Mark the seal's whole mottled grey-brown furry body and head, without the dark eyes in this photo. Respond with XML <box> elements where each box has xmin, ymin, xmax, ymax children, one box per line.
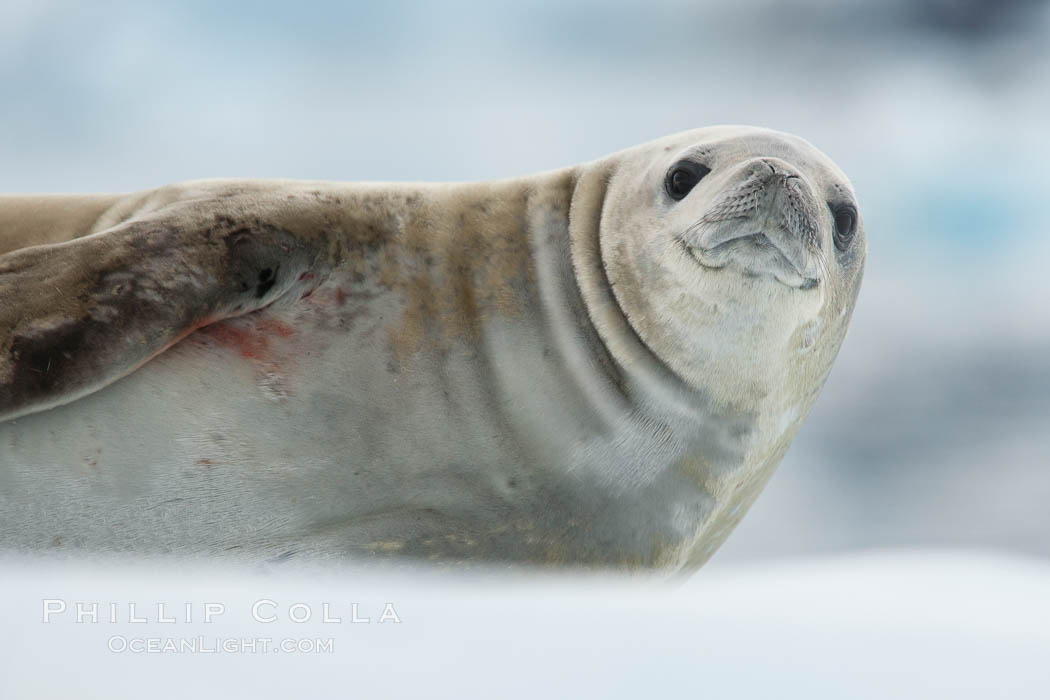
<box><xmin>0</xmin><ymin>127</ymin><xmax>864</xmax><ymax>570</ymax></box>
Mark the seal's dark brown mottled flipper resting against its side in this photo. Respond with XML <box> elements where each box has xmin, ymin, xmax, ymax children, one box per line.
<box><xmin>0</xmin><ymin>203</ymin><xmax>318</xmax><ymax>421</ymax></box>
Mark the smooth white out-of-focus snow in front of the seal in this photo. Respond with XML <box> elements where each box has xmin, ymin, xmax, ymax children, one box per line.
<box><xmin>0</xmin><ymin>550</ymin><xmax>1050</xmax><ymax>700</ymax></box>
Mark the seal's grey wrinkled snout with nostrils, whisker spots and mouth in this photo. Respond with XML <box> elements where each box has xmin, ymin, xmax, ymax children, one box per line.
<box><xmin>685</xmin><ymin>157</ymin><xmax>821</xmax><ymax>289</ymax></box>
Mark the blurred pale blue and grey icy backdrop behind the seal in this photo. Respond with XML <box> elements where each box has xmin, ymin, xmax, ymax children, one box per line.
<box><xmin>0</xmin><ymin>0</ymin><xmax>1050</xmax><ymax>566</ymax></box>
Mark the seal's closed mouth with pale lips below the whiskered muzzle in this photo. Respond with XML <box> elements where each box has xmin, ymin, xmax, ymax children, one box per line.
<box><xmin>683</xmin><ymin>232</ymin><xmax>820</xmax><ymax>290</ymax></box>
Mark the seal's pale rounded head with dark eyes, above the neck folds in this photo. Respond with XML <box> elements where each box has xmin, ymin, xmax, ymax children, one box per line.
<box><xmin>579</xmin><ymin>126</ymin><xmax>865</xmax><ymax>416</ymax></box>
